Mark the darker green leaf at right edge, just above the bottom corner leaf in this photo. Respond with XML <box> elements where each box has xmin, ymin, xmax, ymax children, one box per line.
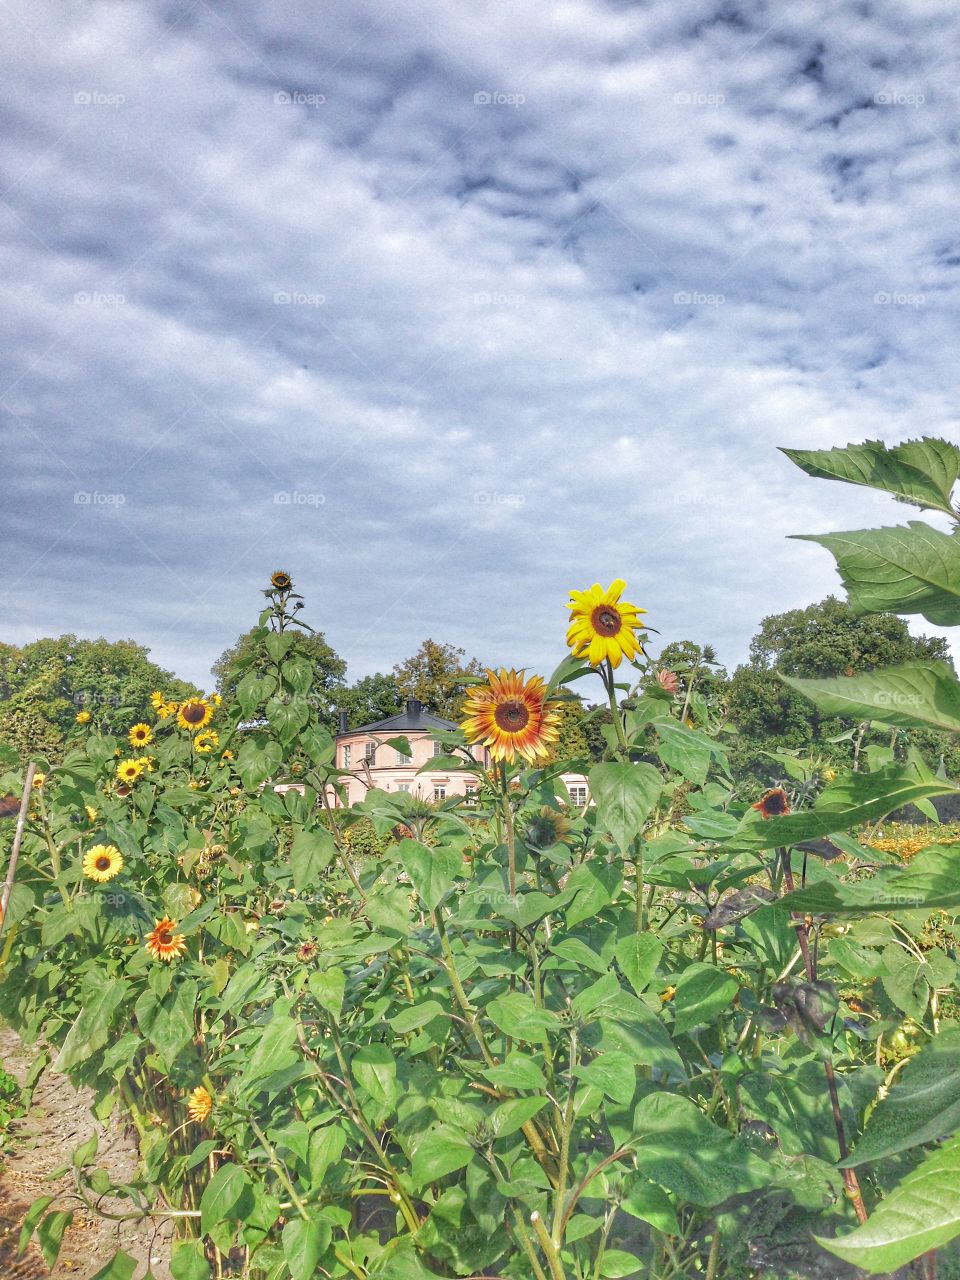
<box><xmin>841</xmin><ymin>1028</ymin><xmax>960</xmax><ymax>1169</ymax></box>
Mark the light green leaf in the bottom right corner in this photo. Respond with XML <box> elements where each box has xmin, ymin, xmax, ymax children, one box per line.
<box><xmin>817</xmin><ymin>1137</ymin><xmax>960</xmax><ymax>1275</ymax></box>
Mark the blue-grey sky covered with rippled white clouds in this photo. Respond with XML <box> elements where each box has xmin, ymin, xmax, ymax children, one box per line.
<box><xmin>0</xmin><ymin>0</ymin><xmax>960</xmax><ymax>684</ymax></box>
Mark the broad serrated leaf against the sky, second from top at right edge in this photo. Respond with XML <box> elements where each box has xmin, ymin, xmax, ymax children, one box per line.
<box><xmin>795</xmin><ymin>520</ymin><xmax>960</xmax><ymax>627</ymax></box>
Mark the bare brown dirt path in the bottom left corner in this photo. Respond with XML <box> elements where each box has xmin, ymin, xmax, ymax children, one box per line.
<box><xmin>0</xmin><ymin>1027</ymin><xmax>170</xmax><ymax>1280</ymax></box>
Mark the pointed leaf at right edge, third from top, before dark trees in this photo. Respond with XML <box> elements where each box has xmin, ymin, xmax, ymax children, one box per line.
<box><xmin>780</xmin><ymin>662</ymin><xmax>960</xmax><ymax>733</ymax></box>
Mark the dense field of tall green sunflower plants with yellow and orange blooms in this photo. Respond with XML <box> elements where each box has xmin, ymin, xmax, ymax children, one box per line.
<box><xmin>0</xmin><ymin>439</ymin><xmax>960</xmax><ymax>1280</ymax></box>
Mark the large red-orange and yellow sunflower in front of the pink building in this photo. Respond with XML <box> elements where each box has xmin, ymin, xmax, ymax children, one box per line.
<box><xmin>461</xmin><ymin>667</ymin><xmax>559</xmax><ymax>764</ymax></box>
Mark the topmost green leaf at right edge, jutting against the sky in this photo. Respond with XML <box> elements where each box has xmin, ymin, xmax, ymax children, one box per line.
<box><xmin>781</xmin><ymin>436</ymin><xmax>960</xmax><ymax>515</ymax></box>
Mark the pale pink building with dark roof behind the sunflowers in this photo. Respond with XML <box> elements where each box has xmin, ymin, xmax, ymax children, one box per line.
<box><xmin>337</xmin><ymin>698</ymin><xmax>588</xmax><ymax>805</ymax></box>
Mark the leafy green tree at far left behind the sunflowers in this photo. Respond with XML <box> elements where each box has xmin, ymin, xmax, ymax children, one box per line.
<box><xmin>0</xmin><ymin>635</ymin><xmax>198</xmax><ymax>759</ymax></box>
